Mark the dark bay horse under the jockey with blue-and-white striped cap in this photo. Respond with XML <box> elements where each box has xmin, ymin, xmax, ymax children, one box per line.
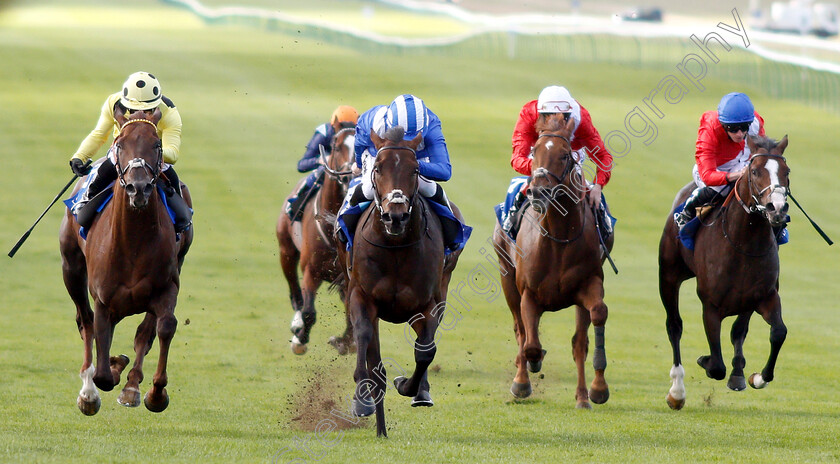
<box><xmin>339</xmin><ymin>126</ymin><xmax>463</xmax><ymax>436</ymax></box>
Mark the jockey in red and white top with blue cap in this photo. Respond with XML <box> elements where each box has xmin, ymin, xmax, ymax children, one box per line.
<box><xmin>674</xmin><ymin>92</ymin><xmax>764</xmax><ymax>229</ymax></box>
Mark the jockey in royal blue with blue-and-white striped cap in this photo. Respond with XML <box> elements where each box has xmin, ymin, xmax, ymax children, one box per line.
<box><xmin>338</xmin><ymin>94</ymin><xmax>466</xmax><ymax>251</ymax></box>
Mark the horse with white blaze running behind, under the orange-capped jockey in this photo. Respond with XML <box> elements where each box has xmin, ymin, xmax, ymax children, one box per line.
<box><xmin>277</xmin><ymin>128</ymin><xmax>356</xmax><ymax>355</ymax></box>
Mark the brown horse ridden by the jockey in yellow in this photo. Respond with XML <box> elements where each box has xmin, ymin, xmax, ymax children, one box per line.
<box><xmin>59</xmin><ymin>111</ymin><xmax>193</xmax><ymax>415</ymax></box>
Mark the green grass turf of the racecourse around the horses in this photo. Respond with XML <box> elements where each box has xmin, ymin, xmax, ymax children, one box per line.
<box><xmin>0</xmin><ymin>2</ymin><xmax>840</xmax><ymax>463</ymax></box>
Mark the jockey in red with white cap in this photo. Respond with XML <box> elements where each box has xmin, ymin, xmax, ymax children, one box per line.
<box><xmin>502</xmin><ymin>85</ymin><xmax>612</xmax><ymax>236</ymax></box>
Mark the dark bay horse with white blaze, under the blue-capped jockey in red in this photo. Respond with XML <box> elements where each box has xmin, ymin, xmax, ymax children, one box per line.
<box><xmin>659</xmin><ymin>136</ymin><xmax>790</xmax><ymax>409</ymax></box>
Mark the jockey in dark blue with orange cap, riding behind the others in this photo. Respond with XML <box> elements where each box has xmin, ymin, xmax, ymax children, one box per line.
<box><xmin>286</xmin><ymin>105</ymin><xmax>359</xmax><ymax>221</ymax></box>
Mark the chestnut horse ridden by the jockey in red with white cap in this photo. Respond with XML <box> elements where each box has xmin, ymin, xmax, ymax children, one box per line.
<box><xmin>493</xmin><ymin>115</ymin><xmax>613</xmax><ymax>409</ymax></box>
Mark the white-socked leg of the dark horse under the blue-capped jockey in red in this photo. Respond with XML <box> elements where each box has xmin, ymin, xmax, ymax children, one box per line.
<box><xmin>659</xmin><ymin>259</ymin><xmax>685</xmax><ymax>410</ymax></box>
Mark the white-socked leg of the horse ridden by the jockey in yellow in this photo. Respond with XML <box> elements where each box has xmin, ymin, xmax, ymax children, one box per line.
<box><xmin>60</xmin><ymin>227</ymin><xmax>102</xmax><ymax>416</ymax></box>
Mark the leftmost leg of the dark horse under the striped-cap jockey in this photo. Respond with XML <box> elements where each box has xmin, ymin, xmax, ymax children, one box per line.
<box><xmin>347</xmin><ymin>290</ymin><xmax>376</xmax><ymax>417</ymax></box>
